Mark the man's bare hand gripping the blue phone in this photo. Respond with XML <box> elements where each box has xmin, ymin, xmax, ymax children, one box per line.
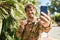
<box><xmin>40</xmin><ymin>11</ymin><xmax>51</xmax><ymax>27</ymax></box>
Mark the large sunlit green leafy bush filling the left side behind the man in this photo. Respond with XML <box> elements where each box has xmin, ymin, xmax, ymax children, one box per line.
<box><xmin>0</xmin><ymin>0</ymin><xmax>38</xmax><ymax>40</ymax></box>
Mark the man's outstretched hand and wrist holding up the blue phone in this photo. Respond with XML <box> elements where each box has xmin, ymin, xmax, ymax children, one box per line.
<box><xmin>39</xmin><ymin>11</ymin><xmax>51</xmax><ymax>32</ymax></box>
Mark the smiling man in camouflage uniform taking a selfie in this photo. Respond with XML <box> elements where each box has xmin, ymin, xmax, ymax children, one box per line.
<box><xmin>16</xmin><ymin>4</ymin><xmax>50</xmax><ymax>40</ymax></box>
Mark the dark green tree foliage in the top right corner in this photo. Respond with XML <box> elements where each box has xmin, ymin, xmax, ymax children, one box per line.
<box><xmin>50</xmin><ymin>0</ymin><xmax>60</xmax><ymax>13</ymax></box>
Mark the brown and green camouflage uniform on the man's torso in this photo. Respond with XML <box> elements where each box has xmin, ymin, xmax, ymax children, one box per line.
<box><xmin>19</xmin><ymin>20</ymin><xmax>50</xmax><ymax>40</ymax></box>
